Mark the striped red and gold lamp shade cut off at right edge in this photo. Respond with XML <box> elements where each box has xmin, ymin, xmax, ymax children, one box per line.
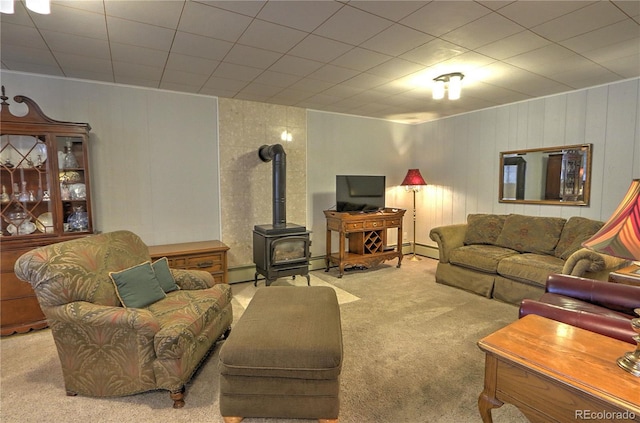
<box><xmin>582</xmin><ymin>179</ymin><xmax>640</xmax><ymax>260</ymax></box>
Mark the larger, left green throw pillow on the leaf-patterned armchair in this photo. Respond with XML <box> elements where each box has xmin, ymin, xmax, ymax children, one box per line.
<box><xmin>109</xmin><ymin>261</ymin><xmax>166</xmax><ymax>308</ymax></box>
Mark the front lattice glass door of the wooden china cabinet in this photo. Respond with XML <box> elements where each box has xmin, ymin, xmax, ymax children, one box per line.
<box><xmin>0</xmin><ymin>134</ymin><xmax>55</xmax><ymax>237</ymax></box>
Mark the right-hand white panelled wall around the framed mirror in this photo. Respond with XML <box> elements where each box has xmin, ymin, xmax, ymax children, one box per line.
<box><xmin>412</xmin><ymin>79</ymin><xmax>640</xmax><ymax>252</ymax></box>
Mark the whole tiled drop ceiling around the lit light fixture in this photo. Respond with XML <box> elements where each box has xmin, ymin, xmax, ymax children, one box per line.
<box><xmin>0</xmin><ymin>0</ymin><xmax>640</xmax><ymax>123</ymax></box>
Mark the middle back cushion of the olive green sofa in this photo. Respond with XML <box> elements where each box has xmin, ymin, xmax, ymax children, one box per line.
<box><xmin>496</xmin><ymin>214</ymin><xmax>566</xmax><ymax>255</ymax></box>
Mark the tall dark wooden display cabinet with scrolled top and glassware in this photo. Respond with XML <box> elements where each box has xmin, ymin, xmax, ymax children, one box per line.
<box><xmin>0</xmin><ymin>87</ymin><xmax>94</xmax><ymax>335</ymax></box>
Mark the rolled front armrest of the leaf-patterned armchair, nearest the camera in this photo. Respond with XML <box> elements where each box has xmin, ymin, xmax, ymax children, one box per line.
<box><xmin>43</xmin><ymin>301</ymin><xmax>160</xmax><ymax>338</ymax></box>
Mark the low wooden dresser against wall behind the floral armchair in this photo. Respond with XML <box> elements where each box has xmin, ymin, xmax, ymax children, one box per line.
<box><xmin>149</xmin><ymin>241</ymin><xmax>229</xmax><ymax>283</ymax></box>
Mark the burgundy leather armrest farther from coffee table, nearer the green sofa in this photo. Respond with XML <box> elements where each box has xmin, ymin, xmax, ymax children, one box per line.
<box><xmin>545</xmin><ymin>274</ymin><xmax>640</xmax><ymax>315</ymax></box>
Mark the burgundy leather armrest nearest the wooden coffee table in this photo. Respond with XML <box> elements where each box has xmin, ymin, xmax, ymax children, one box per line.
<box><xmin>519</xmin><ymin>299</ymin><xmax>636</xmax><ymax>345</ymax></box>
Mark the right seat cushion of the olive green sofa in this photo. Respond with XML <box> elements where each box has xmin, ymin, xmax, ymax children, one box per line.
<box><xmin>498</xmin><ymin>253</ymin><xmax>564</xmax><ymax>286</ymax></box>
